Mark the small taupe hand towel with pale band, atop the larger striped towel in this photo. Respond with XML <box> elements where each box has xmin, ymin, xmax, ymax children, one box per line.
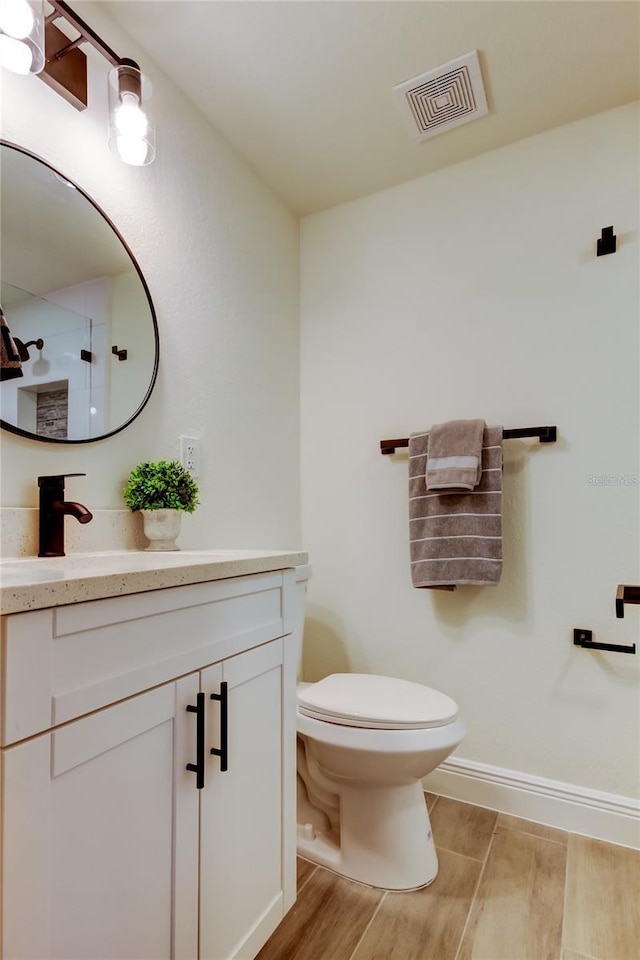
<box><xmin>427</xmin><ymin>420</ymin><xmax>486</xmax><ymax>490</ymax></box>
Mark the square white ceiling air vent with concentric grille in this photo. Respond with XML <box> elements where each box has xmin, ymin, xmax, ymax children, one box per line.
<box><xmin>393</xmin><ymin>50</ymin><xmax>489</xmax><ymax>140</ymax></box>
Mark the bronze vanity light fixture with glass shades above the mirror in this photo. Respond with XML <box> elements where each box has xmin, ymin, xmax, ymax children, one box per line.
<box><xmin>0</xmin><ymin>0</ymin><xmax>156</xmax><ymax>166</ymax></box>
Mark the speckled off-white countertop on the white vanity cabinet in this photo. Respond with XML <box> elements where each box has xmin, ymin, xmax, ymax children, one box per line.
<box><xmin>0</xmin><ymin>550</ymin><xmax>309</xmax><ymax>614</ymax></box>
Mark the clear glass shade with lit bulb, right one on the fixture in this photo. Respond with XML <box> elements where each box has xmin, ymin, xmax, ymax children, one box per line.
<box><xmin>109</xmin><ymin>60</ymin><xmax>156</xmax><ymax>167</ymax></box>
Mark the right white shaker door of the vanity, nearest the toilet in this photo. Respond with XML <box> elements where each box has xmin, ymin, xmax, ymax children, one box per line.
<box><xmin>200</xmin><ymin>640</ymin><xmax>284</xmax><ymax>960</ymax></box>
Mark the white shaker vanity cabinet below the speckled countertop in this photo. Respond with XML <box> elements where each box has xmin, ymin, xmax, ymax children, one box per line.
<box><xmin>1</xmin><ymin>570</ymin><xmax>295</xmax><ymax>960</ymax></box>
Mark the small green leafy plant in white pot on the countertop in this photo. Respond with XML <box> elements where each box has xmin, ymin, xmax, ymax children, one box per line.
<box><xmin>123</xmin><ymin>460</ymin><xmax>200</xmax><ymax>550</ymax></box>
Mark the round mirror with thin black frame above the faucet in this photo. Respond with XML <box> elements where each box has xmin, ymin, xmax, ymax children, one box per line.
<box><xmin>0</xmin><ymin>141</ymin><xmax>159</xmax><ymax>443</ymax></box>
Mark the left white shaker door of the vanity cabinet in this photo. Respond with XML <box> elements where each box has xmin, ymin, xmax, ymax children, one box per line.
<box><xmin>2</xmin><ymin>674</ymin><xmax>199</xmax><ymax>960</ymax></box>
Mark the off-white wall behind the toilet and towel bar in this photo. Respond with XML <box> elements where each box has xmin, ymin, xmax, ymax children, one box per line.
<box><xmin>301</xmin><ymin>105</ymin><xmax>640</xmax><ymax>796</ymax></box>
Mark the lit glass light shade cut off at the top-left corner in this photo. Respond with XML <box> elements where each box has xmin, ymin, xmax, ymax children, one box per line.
<box><xmin>0</xmin><ymin>0</ymin><xmax>44</xmax><ymax>73</ymax></box>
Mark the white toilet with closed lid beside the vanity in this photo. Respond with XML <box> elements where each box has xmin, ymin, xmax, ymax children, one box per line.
<box><xmin>296</xmin><ymin>567</ymin><xmax>465</xmax><ymax>890</ymax></box>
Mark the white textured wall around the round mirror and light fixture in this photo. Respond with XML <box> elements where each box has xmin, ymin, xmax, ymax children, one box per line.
<box><xmin>1</xmin><ymin>4</ymin><xmax>299</xmax><ymax>548</ymax></box>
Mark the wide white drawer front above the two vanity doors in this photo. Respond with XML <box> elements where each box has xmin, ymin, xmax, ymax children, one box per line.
<box><xmin>2</xmin><ymin>571</ymin><xmax>289</xmax><ymax>746</ymax></box>
